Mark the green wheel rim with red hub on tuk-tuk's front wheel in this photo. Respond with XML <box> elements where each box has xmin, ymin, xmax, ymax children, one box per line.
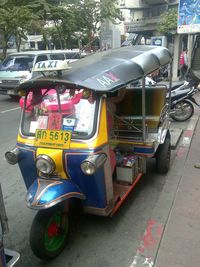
<box><xmin>44</xmin><ymin>211</ymin><xmax>69</xmax><ymax>251</ymax></box>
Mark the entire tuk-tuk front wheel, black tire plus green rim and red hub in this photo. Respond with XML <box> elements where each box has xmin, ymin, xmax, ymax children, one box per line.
<box><xmin>29</xmin><ymin>206</ymin><xmax>69</xmax><ymax>260</ymax></box>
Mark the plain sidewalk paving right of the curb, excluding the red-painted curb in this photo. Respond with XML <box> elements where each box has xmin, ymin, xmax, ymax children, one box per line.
<box><xmin>154</xmin><ymin>112</ymin><xmax>200</xmax><ymax>267</ymax></box>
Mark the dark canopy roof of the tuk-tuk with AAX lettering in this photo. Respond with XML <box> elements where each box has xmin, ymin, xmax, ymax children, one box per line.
<box><xmin>20</xmin><ymin>45</ymin><xmax>172</xmax><ymax>92</ymax></box>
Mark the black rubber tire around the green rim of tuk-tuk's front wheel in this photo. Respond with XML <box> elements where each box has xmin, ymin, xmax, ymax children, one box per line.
<box><xmin>29</xmin><ymin>205</ymin><xmax>69</xmax><ymax>260</ymax></box>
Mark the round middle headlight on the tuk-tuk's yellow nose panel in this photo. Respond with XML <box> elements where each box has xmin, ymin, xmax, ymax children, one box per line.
<box><xmin>35</xmin><ymin>155</ymin><xmax>56</xmax><ymax>174</ymax></box>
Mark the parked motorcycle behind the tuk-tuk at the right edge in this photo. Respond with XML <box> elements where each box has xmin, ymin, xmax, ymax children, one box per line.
<box><xmin>167</xmin><ymin>81</ymin><xmax>200</xmax><ymax>122</ymax></box>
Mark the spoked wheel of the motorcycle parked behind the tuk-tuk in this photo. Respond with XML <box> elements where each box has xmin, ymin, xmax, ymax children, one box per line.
<box><xmin>170</xmin><ymin>100</ymin><xmax>194</xmax><ymax>121</ymax></box>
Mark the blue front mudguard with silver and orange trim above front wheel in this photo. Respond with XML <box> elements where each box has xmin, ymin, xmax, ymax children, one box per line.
<box><xmin>26</xmin><ymin>178</ymin><xmax>85</xmax><ymax>209</ymax></box>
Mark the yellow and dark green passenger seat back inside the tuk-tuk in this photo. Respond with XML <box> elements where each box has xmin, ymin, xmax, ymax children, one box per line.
<box><xmin>114</xmin><ymin>86</ymin><xmax>167</xmax><ymax>139</ymax></box>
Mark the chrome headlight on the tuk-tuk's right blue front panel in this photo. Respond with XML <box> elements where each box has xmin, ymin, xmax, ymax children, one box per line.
<box><xmin>81</xmin><ymin>153</ymin><xmax>107</xmax><ymax>175</ymax></box>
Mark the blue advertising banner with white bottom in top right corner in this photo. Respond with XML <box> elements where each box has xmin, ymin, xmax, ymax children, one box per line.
<box><xmin>177</xmin><ymin>0</ymin><xmax>200</xmax><ymax>33</ymax></box>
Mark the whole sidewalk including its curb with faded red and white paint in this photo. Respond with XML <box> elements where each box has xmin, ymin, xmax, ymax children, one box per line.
<box><xmin>130</xmin><ymin>108</ymin><xmax>200</xmax><ymax>267</ymax></box>
